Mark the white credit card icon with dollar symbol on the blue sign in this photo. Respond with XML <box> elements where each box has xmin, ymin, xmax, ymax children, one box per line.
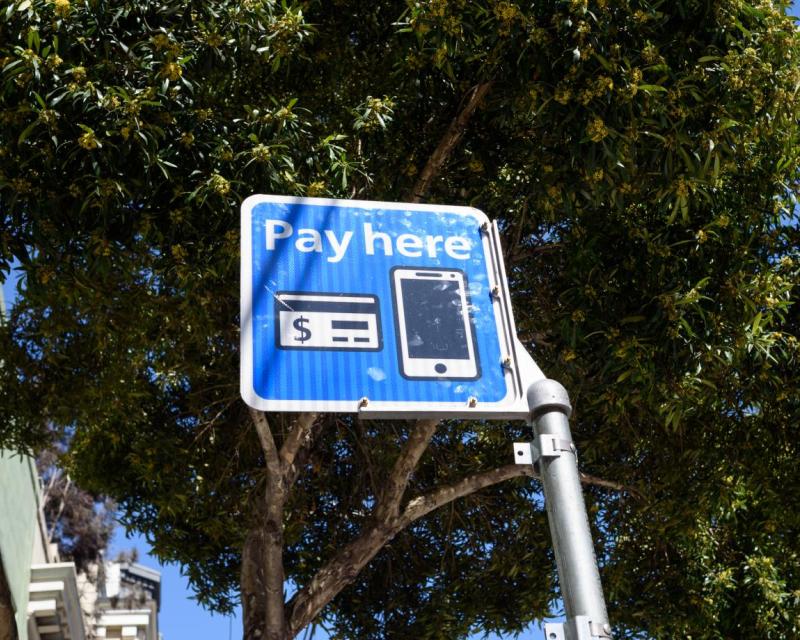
<box><xmin>275</xmin><ymin>291</ymin><xmax>383</xmax><ymax>351</ymax></box>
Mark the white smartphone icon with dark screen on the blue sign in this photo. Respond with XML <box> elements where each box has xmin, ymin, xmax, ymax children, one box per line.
<box><xmin>391</xmin><ymin>267</ymin><xmax>480</xmax><ymax>380</ymax></box>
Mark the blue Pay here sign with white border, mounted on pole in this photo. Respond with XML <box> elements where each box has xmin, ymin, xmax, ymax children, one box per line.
<box><xmin>241</xmin><ymin>195</ymin><xmax>527</xmax><ymax>418</ymax></box>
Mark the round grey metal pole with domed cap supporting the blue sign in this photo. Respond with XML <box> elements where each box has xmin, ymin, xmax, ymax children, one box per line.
<box><xmin>528</xmin><ymin>379</ymin><xmax>611</xmax><ymax>640</ymax></box>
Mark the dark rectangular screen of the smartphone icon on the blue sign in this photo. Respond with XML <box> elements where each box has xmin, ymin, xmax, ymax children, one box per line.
<box><xmin>401</xmin><ymin>279</ymin><xmax>469</xmax><ymax>360</ymax></box>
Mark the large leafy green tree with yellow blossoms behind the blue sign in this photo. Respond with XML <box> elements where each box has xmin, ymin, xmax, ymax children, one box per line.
<box><xmin>0</xmin><ymin>0</ymin><xmax>800</xmax><ymax>638</ymax></box>
